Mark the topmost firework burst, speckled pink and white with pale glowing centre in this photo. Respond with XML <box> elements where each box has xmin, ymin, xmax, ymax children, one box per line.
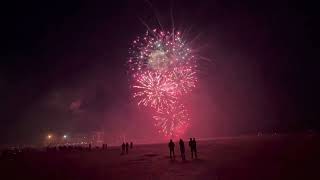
<box><xmin>128</xmin><ymin>29</ymin><xmax>195</xmax><ymax>72</ymax></box>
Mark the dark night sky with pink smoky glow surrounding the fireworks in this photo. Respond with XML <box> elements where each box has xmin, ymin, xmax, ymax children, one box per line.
<box><xmin>0</xmin><ymin>0</ymin><xmax>320</xmax><ymax>144</ymax></box>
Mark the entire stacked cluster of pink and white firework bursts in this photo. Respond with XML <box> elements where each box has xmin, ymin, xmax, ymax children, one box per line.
<box><xmin>128</xmin><ymin>29</ymin><xmax>197</xmax><ymax>137</ymax></box>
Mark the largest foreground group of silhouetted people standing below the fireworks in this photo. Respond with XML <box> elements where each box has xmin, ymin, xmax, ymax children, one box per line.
<box><xmin>168</xmin><ymin>138</ymin><xmax>198</xmax><ymax>161</ymax></box>
